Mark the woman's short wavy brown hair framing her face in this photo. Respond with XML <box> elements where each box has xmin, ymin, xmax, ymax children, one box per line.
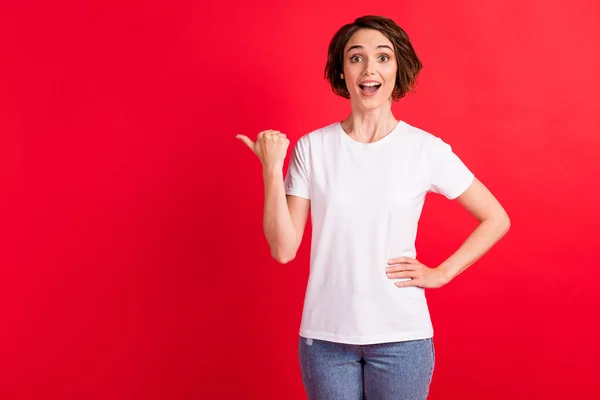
<box><xmin>325</xmin><ymin>15</ymin><xmax>423</xmax><ymax>101</ymax></box>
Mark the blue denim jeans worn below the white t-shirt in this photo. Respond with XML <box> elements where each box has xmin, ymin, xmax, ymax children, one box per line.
<box><xmin>298</xmin><ymin>337</ymin><xmax>435</xmax><ymax>400</ymax></box>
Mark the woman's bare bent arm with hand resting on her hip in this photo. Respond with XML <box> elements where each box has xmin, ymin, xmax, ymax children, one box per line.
<box><xmin>386</xmin><ymin>178</ymin><xmax>510</xmax><ymax>288</ymax></box>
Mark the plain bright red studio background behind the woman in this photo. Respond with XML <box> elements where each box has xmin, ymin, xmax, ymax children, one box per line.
<box><xmin>0</xmin><ymin>0</ymin><xmax>600</xmax><ymax>400</ymax></box>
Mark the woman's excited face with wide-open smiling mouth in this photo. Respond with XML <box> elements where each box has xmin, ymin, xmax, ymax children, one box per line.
<box><xmin>343</xmin><ymin>29</ymin><xmax>398</xmax><ymax>109</ymax></box>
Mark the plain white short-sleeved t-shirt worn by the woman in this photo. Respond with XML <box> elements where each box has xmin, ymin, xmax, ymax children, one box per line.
<box><xmin>285</xmin><ymin>121</ymin><xmax>474</xmax><ymax>344</ymax></box>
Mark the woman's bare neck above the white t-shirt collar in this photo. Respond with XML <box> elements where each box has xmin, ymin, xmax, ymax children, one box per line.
<box><xmin>342</xmin><ymin>107</ymin><xmax>398</xmax><ymax>143</ymax></box>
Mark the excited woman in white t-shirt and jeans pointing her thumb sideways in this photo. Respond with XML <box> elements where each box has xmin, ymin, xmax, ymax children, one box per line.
<box><xmin>237</xmin><ymin>16</ymin><xmax>510</xmax><ymax>400</ymax></box>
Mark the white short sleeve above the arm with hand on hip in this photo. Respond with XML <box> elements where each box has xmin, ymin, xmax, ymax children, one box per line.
<box><xmin>427</xmin><ymin>137</ymin><xmax>475</xmax><ymax>200</ymax></box>
